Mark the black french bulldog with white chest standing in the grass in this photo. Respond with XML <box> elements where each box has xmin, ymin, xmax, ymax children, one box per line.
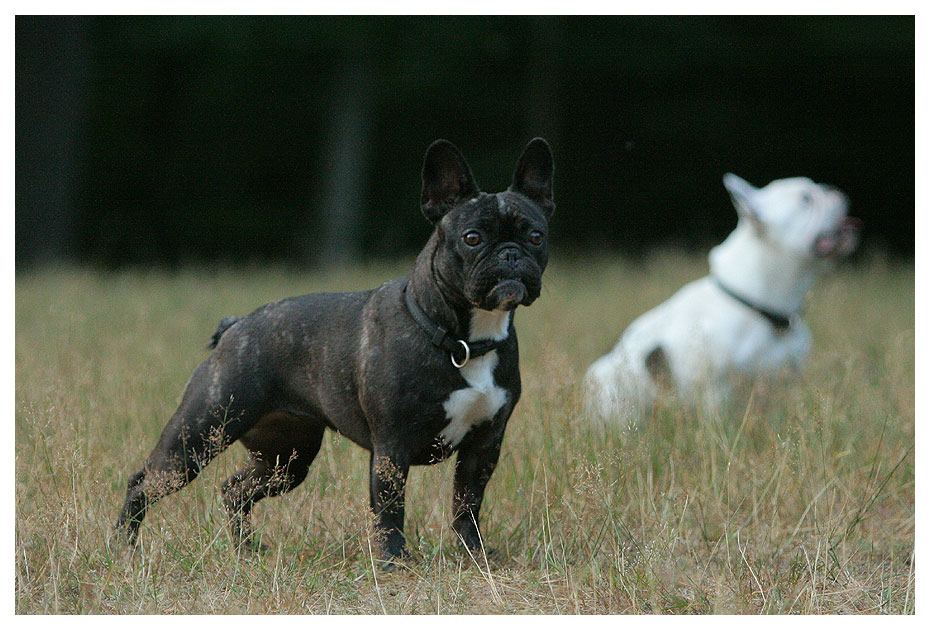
<box><xmin>117</xmin><ymin>138</ymin><xmax>555</xmax><ymax>568</ymax></box>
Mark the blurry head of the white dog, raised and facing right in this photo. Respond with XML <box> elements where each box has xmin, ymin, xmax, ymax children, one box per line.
<box><xmin>723</xmin><ymin>173</ymin><xmax>860</xmax><ymax>259</ymax></box>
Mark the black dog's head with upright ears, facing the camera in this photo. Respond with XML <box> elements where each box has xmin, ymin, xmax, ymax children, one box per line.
<box><xmin>423</xmin><ymin>138</ymin><xmax>555</xmax><ymax>311</ymax></box>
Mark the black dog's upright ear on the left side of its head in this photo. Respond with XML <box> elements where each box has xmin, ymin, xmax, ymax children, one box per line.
<box><xmin>420</xmin><ymin>139</ymin><xmax>481</xmax><ymax>223</ymax></box>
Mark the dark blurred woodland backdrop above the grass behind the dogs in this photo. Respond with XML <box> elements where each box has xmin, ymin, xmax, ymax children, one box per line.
<box><xmin>16</xmin><ymin>16</ymin><xmax>915</xmax><ymax>268</ymax></box>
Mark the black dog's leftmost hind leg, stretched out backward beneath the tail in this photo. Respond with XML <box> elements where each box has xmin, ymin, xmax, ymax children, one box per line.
<box><xmin>116</xmin><ymin>359</ymin><xmax>260</xmax><ymax>545</ymax></box>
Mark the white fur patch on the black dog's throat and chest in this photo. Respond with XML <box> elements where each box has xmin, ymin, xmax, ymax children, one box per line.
<box><xmin>439</xmin><ymin>309</ymin><xmax>510</xmax><ymax>448</ymax></box>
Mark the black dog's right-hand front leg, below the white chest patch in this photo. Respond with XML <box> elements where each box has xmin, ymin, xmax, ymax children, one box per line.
<box><xmin>452</xmin><ymin>427</ymin><xmax>503</xmax><ymax>551</ymax></box>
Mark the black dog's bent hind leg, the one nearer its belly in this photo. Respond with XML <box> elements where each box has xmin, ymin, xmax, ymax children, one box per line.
<box><xmin>223</xmin><ymin>413</ymin><xmax>325</xmax><ymax>551</ymax></box>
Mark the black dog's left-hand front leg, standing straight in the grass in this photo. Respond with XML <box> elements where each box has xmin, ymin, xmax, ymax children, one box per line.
<box><xmin>370</xmin><ymin>449</ymin><xmax>410</xmax><ymax>569</ymax></box>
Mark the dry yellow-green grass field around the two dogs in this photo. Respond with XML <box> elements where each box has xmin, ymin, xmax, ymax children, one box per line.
<box><xmin>15</xmin><ymin>255</ymin><xmax>915</xmax><ymax>613</ymax></box>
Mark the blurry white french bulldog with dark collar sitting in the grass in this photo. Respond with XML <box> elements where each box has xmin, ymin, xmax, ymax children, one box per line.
<box><xmin>585</xmin><ymin>173</ymin><xmax>859</xmax><ymax>424</ymax></box>
